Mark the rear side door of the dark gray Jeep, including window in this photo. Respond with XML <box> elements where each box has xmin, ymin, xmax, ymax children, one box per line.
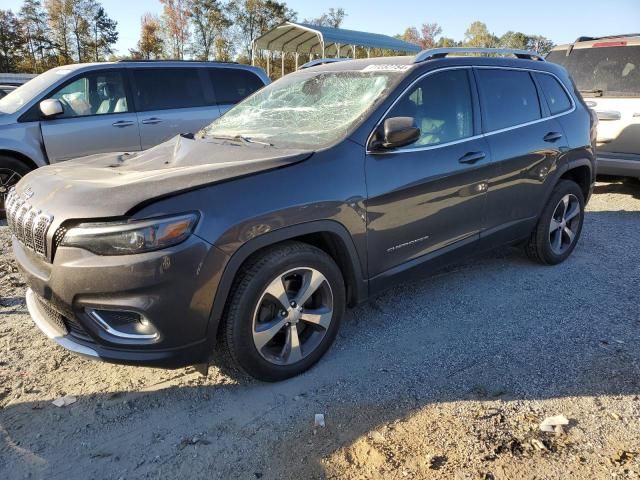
<box><xmin>474</xmin><ymin>67</ymin><xmax>573</xmax><ymax>242</ymax></box>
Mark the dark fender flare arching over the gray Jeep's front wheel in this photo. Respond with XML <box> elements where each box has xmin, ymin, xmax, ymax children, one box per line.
<box><xmin>207</xmin><ymin>220</ymin><xmax>368</xmax><ymax>345</ymax></box>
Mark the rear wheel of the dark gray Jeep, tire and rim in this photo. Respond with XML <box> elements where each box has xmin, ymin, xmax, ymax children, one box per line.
<box><xmin>526</xmin><ymin>180</ymin><xmax>584</xmax><ymax>265</ymax></box>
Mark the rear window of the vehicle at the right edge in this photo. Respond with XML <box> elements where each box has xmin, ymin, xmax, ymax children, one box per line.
<box><xmin>547</xmin><ymin>46</ymin><xmax>640</xmax><ymax>97</ymax></box>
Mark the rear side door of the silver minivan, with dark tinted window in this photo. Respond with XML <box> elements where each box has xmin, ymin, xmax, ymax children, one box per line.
<box><xmin>131</xmin><ymin>66</ymin><xmax>220</xmax><ymax>150</ymax></box>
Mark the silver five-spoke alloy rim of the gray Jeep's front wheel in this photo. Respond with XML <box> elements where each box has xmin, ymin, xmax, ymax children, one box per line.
<box><xmin>252</xmin><ymin>267</ymin><xmax>333</xmax><ymax>365</ymax></box>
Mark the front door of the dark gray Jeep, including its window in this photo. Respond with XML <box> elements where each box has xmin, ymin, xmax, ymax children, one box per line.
<box><xmin>366</xmin><ymin>68</ymin><xmax>493</xmax><ymax>277</ymax></box>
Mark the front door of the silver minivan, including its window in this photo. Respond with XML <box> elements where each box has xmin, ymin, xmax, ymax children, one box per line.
<box><xmin>40</xmin><ymin>70</ymin><xmax>140</xmax><ymax>163</ymax></box>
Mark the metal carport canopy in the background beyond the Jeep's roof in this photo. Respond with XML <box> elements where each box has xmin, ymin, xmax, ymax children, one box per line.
<box><xmin>253</xmin><ymin>22</ymin><xmax>420</xmax><ymax>57</ymax></box>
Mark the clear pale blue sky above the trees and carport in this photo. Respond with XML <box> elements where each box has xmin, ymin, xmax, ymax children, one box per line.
<box><xmin>0</xmin><ymin>0</ymin><xmax>640</xmax><ymax>54</ymax></box>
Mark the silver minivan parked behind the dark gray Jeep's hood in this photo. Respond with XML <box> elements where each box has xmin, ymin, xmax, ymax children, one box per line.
<box><xmin>0</xmin><ymin>61</ymin><xmax>269</xmax><ymax>216</ymax></box>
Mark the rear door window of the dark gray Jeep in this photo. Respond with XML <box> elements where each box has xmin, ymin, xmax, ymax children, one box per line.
<box><xmin>477</xmin><ymin>69</ymin><xmax>542</xmax><ymax>131</ymax></box>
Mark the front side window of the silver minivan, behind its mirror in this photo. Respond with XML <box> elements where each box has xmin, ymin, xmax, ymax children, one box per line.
<box><xmin>50</xmin><ymin>72</ymin><xmax>129</xmax><ymax>118</ymax></box>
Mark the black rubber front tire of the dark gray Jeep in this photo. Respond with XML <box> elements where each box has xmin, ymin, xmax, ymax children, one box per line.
<box><xmin>218</xmin><ymin>241</ymin><xmax>346</xmax><ymax>382</ymax></box>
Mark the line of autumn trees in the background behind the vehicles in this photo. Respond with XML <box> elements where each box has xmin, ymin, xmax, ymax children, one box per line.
<box><xmin>0</xmin><ymin>0</ymin><xmax>553</xmax><ymax>73</ymax></box>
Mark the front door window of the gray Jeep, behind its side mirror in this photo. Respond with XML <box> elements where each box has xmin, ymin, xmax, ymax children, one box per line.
<box><xmin>388</xmin><ymin>69</ymin><xmax>473</xmax><ymax>148</ymax></box>
